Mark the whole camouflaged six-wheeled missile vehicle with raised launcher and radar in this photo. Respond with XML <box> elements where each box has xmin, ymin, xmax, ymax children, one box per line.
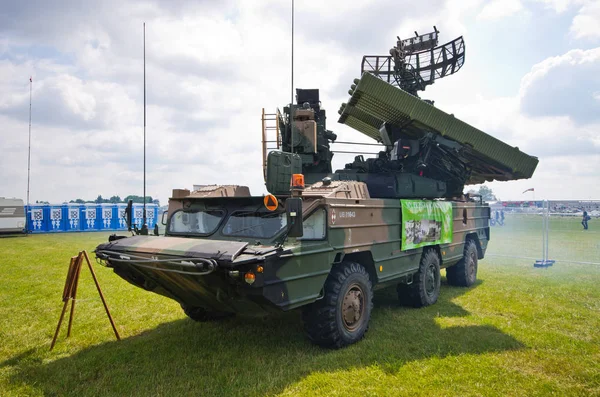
<box><xmin>96</xmin><ymin>29</ymin><xmax>537</xmax><ymax>348</ymax></box>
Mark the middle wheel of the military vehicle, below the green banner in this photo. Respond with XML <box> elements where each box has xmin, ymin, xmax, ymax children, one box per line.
<box><xmin>398</xmin><ymin>249</ymin><xmax>440</xmax><ymax>307</ymax></box>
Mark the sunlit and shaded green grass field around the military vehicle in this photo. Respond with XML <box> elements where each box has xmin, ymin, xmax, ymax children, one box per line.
<box><xmin>0</xmin><ymin>216</ymin><xmax>600</xmax><ymax>396</ymax></box>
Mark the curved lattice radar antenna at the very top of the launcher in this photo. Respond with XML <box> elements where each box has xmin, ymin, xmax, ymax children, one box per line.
<box><xmin>360</xmin><ymin>26</ymin><xmax>465</xmax><ymax>97</ymax></box>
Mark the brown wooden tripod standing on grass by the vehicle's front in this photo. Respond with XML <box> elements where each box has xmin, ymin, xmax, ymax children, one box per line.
<box><xmin>50</xmin><ymin>251</ymin><xmax>121</xmax><ymax>350</ymax></box>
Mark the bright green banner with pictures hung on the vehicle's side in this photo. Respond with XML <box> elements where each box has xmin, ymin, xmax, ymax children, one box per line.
<box><xmin>400</xmin><ymin>200</ymin><xmax>452</xmax><ymax>250</ymax></box>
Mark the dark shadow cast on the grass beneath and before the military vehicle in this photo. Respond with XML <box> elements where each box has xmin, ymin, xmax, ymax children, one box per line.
<box><xmin>0</xmin><ymin>280</ymin><xmax>523</xmax><ymax>396</ymax></box>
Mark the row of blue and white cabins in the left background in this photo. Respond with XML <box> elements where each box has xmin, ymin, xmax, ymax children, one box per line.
<box><xmin>25</xmin><ymin>203</ymin><xmax>158</xmax><ymax>233</ymax></box>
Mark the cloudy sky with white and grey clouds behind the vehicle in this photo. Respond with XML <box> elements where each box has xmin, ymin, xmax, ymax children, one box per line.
<box><xmin>0</xmin><ymin>0</ymin><xmax>600</xmax><ymax>204</ymax></box>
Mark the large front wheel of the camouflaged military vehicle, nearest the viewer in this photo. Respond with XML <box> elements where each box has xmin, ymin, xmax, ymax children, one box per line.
<box><xmin>302</xmin><ymin>262</ymin><xmax>373</xmax><ymax>349</ymax></box>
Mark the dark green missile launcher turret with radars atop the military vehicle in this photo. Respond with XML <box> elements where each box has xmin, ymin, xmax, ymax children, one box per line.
<box><xmin>264</xmin><ymin>26</ymin><xmax>538</xmax><ymax>198</ymax></box>
